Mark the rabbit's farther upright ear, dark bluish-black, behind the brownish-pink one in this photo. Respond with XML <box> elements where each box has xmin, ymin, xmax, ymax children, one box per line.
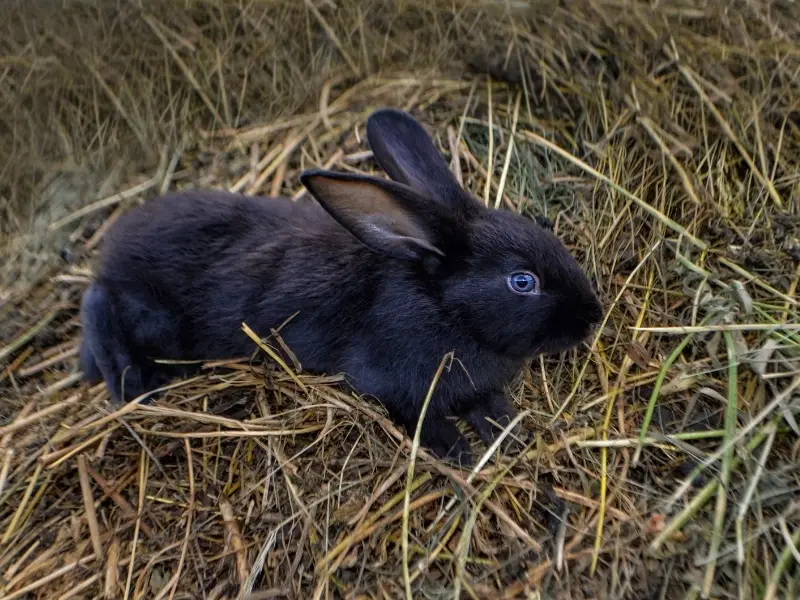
<box><xmin>367</xmin><ymin>108</ymin><xmax>467</xmax><ymax>208</ymax></box>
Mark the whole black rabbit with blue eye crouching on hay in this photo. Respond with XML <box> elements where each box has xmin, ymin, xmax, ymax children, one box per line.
<box><xmin>81</xmin><ymin>109</ymin><xmax>602</xmax><ymax>463</ymax></box>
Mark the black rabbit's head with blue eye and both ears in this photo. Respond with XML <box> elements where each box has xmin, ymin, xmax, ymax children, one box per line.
<box><xmin>301</xmin><ymin>109</ymin><xmax>603</xmax><ymax>359</ymax></box>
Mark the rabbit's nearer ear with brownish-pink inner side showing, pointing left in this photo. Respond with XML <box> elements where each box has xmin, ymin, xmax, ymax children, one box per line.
<box><xmin>300</xmin><ymin>171</ymin><xmax>444</xmax><ymax>260</ymax></box>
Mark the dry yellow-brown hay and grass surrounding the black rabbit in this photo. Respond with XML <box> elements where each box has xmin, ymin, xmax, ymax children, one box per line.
<box><xmin>0</xmin><ymin>0</ymin><xmax>800</xmax><ymax>600</ymax></box>
